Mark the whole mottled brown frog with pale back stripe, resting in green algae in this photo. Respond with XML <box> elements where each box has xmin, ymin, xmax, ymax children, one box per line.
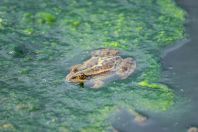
<box><xmin>66</xmin><ymin>49</ymin><xmax>136</xmax><ymax>88</ymax></box>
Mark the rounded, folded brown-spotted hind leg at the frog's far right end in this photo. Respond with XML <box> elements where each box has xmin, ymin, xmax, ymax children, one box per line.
<box><xmin>116</xmin><ymin>58</ymin><xmax>136</xmax><ymax>79</ymax></box>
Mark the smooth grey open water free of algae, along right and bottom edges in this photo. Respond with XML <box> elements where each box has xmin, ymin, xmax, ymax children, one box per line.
<box><xmin>115</xmin><ymin>0</ymin><xmax>198</xmax><ymax>132</ymax></box>
